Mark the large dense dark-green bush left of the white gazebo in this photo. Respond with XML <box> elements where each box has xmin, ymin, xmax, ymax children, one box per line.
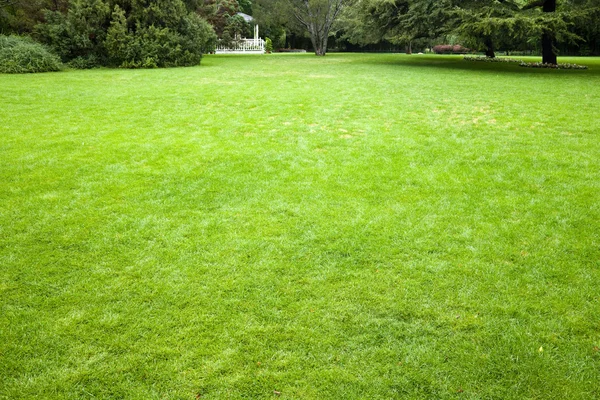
<box><xmin>32</xmin><ymin>0</ymin><xmax>215</xmax><ymax>68</ymax></box>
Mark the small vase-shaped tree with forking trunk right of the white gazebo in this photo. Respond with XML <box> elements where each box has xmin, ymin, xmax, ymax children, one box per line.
<box><xmin>289</xmin><ymin>0</ymin><xmax>347</xmax><ymax>56</ymax></box>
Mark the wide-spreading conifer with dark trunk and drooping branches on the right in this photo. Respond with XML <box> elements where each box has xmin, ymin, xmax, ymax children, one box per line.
<box><xmin>347</xmin><ymin>0</ymin><xmax>600</xmax><ymax>64</ymax></box>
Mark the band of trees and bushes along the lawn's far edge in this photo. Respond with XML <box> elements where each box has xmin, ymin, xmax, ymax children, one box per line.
<box><xmin>0</xmin><ymin>0</ymin><xmax>600</xmax><ymax>67</ymax></box>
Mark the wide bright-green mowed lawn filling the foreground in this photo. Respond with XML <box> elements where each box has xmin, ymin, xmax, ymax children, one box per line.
<box><xmin>0</xmin><ymin>54</ymin><xmax>600</xmax><ymax>399</ymax></box>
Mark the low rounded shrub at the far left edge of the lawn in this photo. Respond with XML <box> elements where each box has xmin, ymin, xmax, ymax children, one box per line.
<box><xmin>0</xmin><ymin>35</ymin><xmax>62</xmax><ymax>74</ymax></box>
